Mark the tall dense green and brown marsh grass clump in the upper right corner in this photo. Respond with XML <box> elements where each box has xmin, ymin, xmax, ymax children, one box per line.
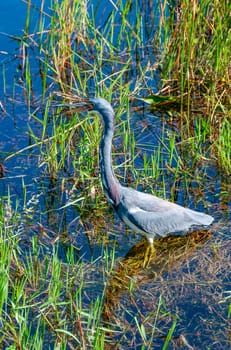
<box><xmin>156</xmin><ymin>1</ymin><xmax>231</xmax><ymax>174</ymax></box>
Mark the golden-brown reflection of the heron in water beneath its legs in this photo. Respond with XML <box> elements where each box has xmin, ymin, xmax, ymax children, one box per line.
<box><xmin>103</xmin><ymin>230</ymin><xmax>212</xmax><ymax>321</ymax></box>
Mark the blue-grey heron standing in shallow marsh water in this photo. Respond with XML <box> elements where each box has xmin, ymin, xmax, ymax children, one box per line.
<box><xmin>67</xmin><ymin>97</ymin><xmax>214</xmax><ymax>264</ymax></box>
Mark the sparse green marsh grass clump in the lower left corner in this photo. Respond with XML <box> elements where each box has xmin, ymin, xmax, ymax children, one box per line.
<box><xmin>0</xmin><ymin>199</ymin><xmax>111</xmax><ymax>349</ymax></box>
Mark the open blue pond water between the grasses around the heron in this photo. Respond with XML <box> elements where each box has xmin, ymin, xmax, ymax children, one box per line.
<box><xmin>0</xmin><ymin>0</ymin><xmax>231</xmax><ymax>349</ymax></box>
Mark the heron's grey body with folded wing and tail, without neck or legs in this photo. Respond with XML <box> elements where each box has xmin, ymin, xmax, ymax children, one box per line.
<box><xmin>121</xmin><ymin>189</ymin><xmax>213</xmax><ymax>236</ymax></box>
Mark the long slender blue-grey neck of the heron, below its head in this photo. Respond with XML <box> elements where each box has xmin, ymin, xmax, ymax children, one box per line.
<box><xmin>100</xmin><ymin>125</ymin><xmax>120</xmax><ymax>206</ymax></box>
